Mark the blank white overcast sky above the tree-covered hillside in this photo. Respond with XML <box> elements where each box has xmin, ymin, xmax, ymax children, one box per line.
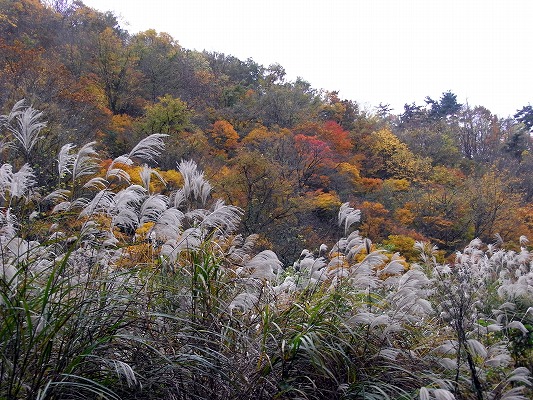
<box><xmin>83</xmin><ymin>0</ymin><xmax>533</xmax><ymax>117</ymax></box>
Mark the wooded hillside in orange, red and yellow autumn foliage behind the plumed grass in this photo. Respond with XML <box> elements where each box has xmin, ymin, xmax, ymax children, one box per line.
<box><xmin>0</xmin><ymin>1</ymin><xmax>533</xmax><ymax>260</ymax></box>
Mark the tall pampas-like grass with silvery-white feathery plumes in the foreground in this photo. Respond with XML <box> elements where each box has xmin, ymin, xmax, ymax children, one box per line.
<box><xmin>0</xmin><ymin>103</ymin><xmax>533</xmax><ymax>400</ymax></box>
